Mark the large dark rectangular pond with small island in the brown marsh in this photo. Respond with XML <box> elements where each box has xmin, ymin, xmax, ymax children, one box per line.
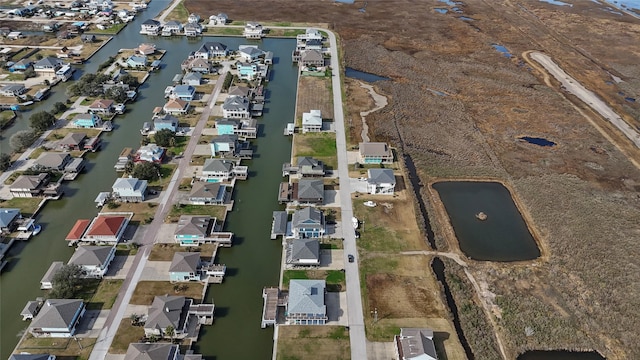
<box><xmin>433</xmin><ymin>181</ymin><xmax>540</xmax><ymax>261</ymax></box>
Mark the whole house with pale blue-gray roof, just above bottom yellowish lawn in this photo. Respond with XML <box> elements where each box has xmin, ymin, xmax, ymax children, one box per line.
<box><xmin>286</xmin><ymin>279</ymin><xmax>328</xmax><ymax>325</ymax></box>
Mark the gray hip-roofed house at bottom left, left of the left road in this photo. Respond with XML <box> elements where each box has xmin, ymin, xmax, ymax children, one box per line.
<box><xmin>29</xmin><ymin>299</ymin><xmax>86</xmax><ymax>338</ymax></box>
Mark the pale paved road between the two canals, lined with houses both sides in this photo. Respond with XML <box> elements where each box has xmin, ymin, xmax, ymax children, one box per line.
<box><xmin>89</xmin><ymin>72</ymin><xmax>226</xmax><ymax>360</ymax></box>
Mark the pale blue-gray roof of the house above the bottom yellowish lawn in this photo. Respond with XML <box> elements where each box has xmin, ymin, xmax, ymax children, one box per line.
<box><xmin>287</xmin><ymin>280</ymin><xmax>327</xmax><ymax>314</ymax></box>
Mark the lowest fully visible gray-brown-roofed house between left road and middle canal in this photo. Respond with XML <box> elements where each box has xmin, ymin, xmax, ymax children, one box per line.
<box><xmin>144</xmin><ymin>295</ymin><xmax>193</xmax><ymax>338</ymax></box>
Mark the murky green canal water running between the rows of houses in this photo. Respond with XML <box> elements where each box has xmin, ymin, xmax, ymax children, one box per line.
<box><xmin>0</xmin><ymin>0</ymin><xmax>297</xmax><ymax>360</ymax></box>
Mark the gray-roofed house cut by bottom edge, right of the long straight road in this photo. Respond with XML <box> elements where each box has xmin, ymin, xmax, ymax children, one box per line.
<box><xmin>393</xmin><ymin>328</ymin><xmax>438</xmax><ymax>360</ymax></box>
